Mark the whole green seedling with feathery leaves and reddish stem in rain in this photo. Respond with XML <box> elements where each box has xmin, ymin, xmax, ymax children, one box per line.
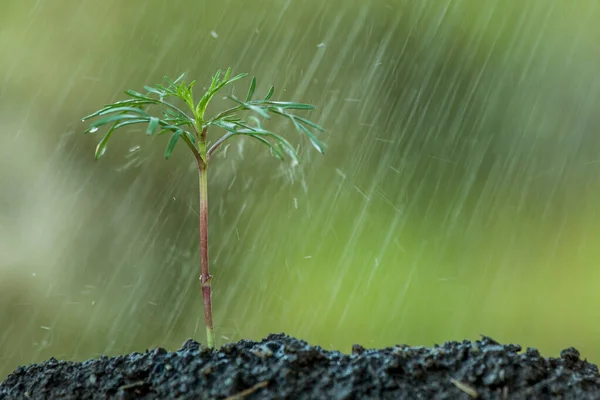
<box><xmin>82</xmin><ymin>68</ymin><xmax>324</xmax><ymax>348</ymax></box>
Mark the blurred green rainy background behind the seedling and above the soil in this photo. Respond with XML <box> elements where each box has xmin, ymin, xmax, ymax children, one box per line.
<box><xmin>0</xmin><ymin>0</ymin><xmax>600</xmax><ymax>379</ymax></box>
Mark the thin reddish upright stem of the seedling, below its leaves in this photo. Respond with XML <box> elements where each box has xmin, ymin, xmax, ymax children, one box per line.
<box><xmin>198</xmin><ymin>160</ymin><xmax>215</xmax><ymax>348</ymax></box>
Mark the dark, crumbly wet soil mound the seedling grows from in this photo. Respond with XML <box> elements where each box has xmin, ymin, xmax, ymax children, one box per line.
<box><xmin>0</xmin><ymin>334</ymin><xmax>600</xmax><ymax>400</ymax></box>
